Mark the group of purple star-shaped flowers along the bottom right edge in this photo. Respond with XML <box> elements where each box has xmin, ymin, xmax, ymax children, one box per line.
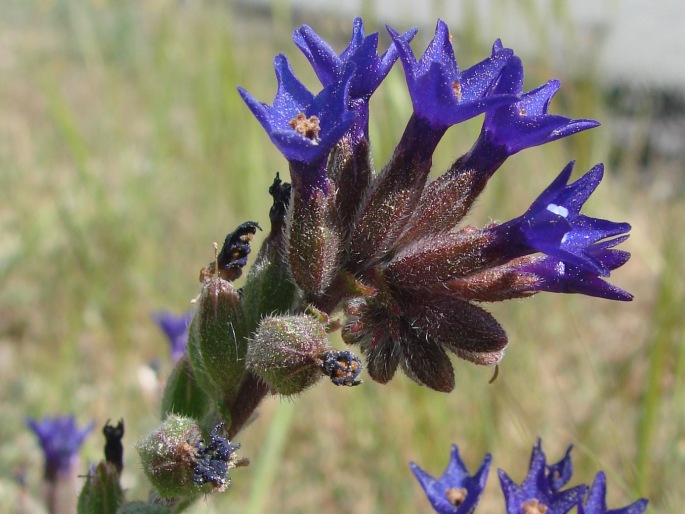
<box><xmin>410</xmin><ymin>440</ymin><xmax>647</xmax><ymax>514</ymax></box>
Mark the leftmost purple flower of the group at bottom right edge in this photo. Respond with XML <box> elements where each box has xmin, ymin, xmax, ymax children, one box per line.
<box><xmin>409</xmin><ymin>444</ymin><xmax>492</xmax><ymax>514</ymax></box>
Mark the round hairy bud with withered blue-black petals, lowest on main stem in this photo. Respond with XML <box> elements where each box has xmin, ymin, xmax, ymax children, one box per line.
<box><xmin>136</xmin><ymin>415</ymin><xmax>245</xmax><ymax>498</ymax></box>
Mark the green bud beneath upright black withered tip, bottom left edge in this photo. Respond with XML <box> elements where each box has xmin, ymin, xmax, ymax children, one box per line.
<box><xmin>78</xmin><ymin>461</ymin><xmax>124</xmax><ymax>514</ymax></box>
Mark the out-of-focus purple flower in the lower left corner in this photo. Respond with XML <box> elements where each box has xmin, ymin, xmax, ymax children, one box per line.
<box><xmin>26</xmin><ymin>415</ymin><xmax>95</xmax><ymax>482</ymax></box>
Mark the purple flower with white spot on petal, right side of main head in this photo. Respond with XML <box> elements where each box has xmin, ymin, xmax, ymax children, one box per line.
<box><xmin>492</xmin><ymin>162</ymin><xmax>630</xmax><ymax>276</ymax></box>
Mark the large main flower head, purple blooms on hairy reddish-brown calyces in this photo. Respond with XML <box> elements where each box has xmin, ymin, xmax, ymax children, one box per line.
<box><xmin>239</xmin><ymin>19</ymin><xmax>632</xmax><ymax>392</ymax></box>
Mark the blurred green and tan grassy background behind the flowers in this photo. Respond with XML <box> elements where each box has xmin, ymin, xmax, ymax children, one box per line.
<box><xmin>0</xmin><ymin>0</ymin><xmax>685</xmax><ymax>514</ymax></box>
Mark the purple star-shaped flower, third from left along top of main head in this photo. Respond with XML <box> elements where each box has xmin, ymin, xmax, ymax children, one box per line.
<box><xmin>388</xmin><ymin>20</ymin><xmax>517</xmax><ymax>130</ymax></box>
